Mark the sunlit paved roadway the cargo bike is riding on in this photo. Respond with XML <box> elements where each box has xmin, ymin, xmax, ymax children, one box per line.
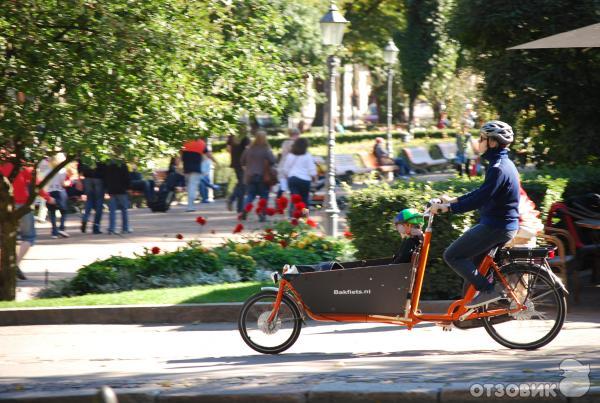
<box><xmin>0</xmin><ymin>313</ymin><xmax>600</xmax><ymax>400</ymax></box>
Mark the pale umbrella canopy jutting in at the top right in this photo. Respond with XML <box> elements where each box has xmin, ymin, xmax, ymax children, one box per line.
<box><xmin>508</xmin><ymin>23</ymin><xmax>600</xmax><ymax>50</ymax></box>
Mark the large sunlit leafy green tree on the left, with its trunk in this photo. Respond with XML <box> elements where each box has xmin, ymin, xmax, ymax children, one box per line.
<box><xmin>0</xmin><ymin>0</ymin><xmax>318</xmax><ymax>298</ymax></box>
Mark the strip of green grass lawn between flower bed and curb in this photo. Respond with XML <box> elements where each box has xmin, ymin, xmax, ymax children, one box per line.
<box><xmin>0</xmin><ymin>282</ymin><xmax>273</xmax><ymax>308</ymax></box>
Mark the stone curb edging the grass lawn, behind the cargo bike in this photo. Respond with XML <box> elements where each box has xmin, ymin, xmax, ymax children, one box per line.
<box><xmin>0</xmin><ymin>301</ymin><xmax>450</xmax><ymax>326</ymax></box>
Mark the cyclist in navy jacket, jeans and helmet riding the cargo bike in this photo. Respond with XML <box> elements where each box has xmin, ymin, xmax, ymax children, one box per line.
<box><xmin>431</xmin><ymin>120</ymin><xmax>519</xmax><ymax>308</ymax></box>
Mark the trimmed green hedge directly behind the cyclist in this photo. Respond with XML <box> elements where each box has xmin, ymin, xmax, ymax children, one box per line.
<box><xmin>348</xmin><ymin>167</ymin><xmax>600</xmax><ymax>299</ymax></box>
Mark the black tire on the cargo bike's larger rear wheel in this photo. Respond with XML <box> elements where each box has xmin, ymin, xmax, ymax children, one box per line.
<box><xmin>481</xmin><ymin>264</ymin><xmax>567</xmax><ymax>350</ymax></box>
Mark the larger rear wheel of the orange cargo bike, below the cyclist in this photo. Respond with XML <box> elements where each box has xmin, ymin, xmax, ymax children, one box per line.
<box><xmin>482</xmin><ymin>265</ymin><xmax>567</xmax><ymax>350</ymax></box>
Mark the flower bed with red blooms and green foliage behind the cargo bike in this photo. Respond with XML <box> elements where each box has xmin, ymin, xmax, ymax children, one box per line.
<box><xmin>39</xmin><ymin>198</ymin><xmax>354</xmax><ymax>297</ymax></box>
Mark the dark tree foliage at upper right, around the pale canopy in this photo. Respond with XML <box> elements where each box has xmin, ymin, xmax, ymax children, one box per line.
<box><xmin>453</xmin><ymin>0</ymin><xmax>600</xmax><ymax>163</ymax></box>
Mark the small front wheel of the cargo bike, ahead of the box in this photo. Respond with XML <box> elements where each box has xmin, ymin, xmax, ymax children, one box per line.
<box><xmin>238</xmin><ymin>291</ymin><xmax>302</xmax><ymax>354</ymax></box>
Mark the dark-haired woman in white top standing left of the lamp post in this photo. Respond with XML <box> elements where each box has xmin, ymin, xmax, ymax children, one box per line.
<box><xmin>282</xmin><ymin>137</ymin><xmax>317</xmax><ymax>207</ymax></box>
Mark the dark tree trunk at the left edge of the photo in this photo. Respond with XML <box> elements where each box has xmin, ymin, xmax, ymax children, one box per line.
<box><xmin>0</xmin><ymin>175</ymin><xmax>19</xmax><ymax>301</ymax></box>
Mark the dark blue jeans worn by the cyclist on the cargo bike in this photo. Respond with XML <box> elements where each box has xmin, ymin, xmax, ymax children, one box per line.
<box><xmin>444</xmin><ymin>224</ymin><xmax>517</xmax><ymax>291</ymax></box>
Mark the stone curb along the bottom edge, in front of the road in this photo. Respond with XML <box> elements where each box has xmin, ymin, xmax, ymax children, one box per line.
<box><xmin>0</xmin><ymin>383</ymin><xmax>600</xmax><ymax>403</ymax></box>
